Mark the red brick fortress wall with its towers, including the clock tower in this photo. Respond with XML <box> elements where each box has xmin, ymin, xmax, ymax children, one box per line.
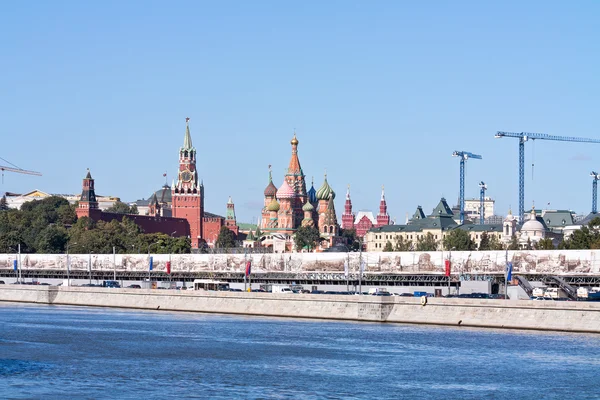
<box><xmin>77</xmin><ymin>118</ymin><xmax>239</xmax><ymax>249</ymax></box>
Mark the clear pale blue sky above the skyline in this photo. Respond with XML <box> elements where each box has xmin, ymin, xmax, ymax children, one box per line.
<box><xmin>0</xmin><ymin>1</ymin><xmax>600</xmax><ymax>223</ymax></box>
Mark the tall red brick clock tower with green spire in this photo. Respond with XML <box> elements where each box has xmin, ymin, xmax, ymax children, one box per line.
<box><xmin>171</xmin><ymin>118</ymin><xmax>204</xmax><ymax>249</ymax></box>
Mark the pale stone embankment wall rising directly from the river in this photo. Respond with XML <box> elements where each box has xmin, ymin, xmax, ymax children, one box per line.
<box><xmin>0</xmin><ymin>285</ymin><xmax>600</xmax><ymax>333</ymax></box>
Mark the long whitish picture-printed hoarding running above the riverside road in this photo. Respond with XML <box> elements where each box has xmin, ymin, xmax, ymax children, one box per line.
<box><xmin>0</xmin><ymin>250</ymin><xmax>600</xmax><ymax>276</ymax></box>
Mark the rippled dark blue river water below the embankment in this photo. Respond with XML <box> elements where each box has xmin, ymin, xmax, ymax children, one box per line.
<box><xmin>0</xmin><ymin>303</ymin><xmax>600</xmax><ymax>400</ymax></box>
